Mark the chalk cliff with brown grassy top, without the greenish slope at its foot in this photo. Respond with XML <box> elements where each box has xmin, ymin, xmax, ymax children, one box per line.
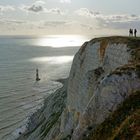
<box><xmin>61</xmin><ymin>37</ymin><xmax>140</xmax><ymax>140</ymax></box>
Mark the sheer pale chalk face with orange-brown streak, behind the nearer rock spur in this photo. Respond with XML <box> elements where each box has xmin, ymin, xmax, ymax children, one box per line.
<box><xmin>61</xmin><ymin>37</ymin><xmax>131</xmax><ymax>136</ymax></box>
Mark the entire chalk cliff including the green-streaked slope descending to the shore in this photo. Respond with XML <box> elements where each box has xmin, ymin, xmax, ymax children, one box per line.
<box><xmin>12</xmin><ymin>36</ymin><xmax>140</xmax><ymax>140</ymax></box>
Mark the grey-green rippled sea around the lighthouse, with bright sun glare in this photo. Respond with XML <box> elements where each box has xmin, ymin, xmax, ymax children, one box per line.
<box><xmin>0</xmin><ymin>35</ymin><xmax>88</xmax><ymax>140</ymax></box>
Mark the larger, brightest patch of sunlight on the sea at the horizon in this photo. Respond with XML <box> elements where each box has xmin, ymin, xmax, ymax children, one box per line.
<box><xmin>36</xmin><ymin>35</ymin><xmax>87</xmax><ymax>48</ymax></box>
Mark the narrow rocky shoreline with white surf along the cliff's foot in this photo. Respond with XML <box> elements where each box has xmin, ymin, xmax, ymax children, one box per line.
<box><xmin>4</xmin><ymin>78</ymin><xmax>67</xmax><ymax>140</ymax></box>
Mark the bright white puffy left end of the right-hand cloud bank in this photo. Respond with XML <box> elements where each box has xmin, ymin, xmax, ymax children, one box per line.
<box><xmin>75</xmin><ymin>8</ymin><xmax>100</xmax><ymax>18</ymax></box>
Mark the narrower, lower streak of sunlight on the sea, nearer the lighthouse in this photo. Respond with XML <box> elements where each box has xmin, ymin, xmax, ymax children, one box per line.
<box><xmin>30</xmin><ymin>56</ymin><xmax>73</xmax><ymax>64</ymax></box>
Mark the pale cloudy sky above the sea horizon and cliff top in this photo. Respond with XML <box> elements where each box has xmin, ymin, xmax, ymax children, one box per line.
<box><xmin>0</xmin><ymin>0</ymin><xmax>140</xmax><ymax>36</ymax></box>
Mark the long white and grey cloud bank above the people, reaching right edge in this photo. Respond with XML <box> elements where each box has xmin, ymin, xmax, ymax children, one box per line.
<box><xmin>75</xmin><ymin>8</ymin><xmax>140</xmax><ymax>29</ymax></box>
